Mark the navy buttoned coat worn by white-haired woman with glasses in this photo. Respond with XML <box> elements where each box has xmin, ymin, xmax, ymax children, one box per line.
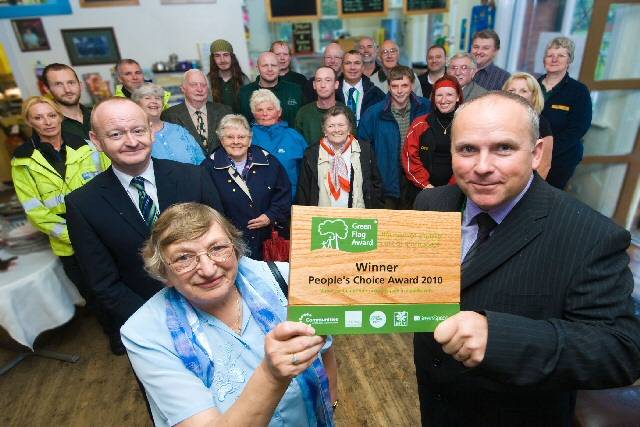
<box><xmin>202</xmin><ymin>146</ymin><xmax>291</xmax><ymax>260</ymax></box>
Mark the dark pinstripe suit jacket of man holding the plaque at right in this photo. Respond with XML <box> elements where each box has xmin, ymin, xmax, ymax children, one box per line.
<box><xmin>414</xmin><ymin>175</ymin><xmax>640</xmax><ymax>427</ymax></box>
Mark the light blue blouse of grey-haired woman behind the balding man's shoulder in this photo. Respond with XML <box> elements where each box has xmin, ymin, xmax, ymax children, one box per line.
<box><xmin>151</xmin><ymin>122</ymin><xmax>204</xmax><ymax>165</ymax></box>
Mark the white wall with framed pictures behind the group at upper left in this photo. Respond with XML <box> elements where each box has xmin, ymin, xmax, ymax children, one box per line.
<box><xmin>0</xmin><ymin>0</ymin><xmax>249</xmax><ymax>103</ymax></box>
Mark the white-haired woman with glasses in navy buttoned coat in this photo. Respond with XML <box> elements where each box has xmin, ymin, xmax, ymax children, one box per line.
<box><xmin>202</xmin><ymin>114</ymin><xmax>291</xmax><ymax>260</ymax></box>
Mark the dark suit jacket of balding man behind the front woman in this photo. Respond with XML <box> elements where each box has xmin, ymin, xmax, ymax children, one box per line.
<box><xmin>65</xmin><ymin>159</ymin><xmax>224</xmax><ymax>330</ymax></box>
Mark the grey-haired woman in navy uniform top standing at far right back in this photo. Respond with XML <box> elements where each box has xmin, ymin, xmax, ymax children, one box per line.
<box><xmin>538</xmin><ymin>37</ymin><xmax>592</xmax><ymax>189</ymax></box>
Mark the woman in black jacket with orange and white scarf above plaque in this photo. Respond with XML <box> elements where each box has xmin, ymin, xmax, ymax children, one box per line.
<box><xmin>296</xmin><ymin>105</ymin><xmax>383</xmax><ymax>209</ymax></box>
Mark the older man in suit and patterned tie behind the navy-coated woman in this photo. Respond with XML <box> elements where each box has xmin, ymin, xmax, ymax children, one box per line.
<box><xmin>161</xmin><ymin>70</ymin><xmax>232</xmax><ymax>156</ymax></box>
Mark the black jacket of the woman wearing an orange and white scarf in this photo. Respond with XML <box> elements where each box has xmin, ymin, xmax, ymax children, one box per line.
<box><xmin>296</xmin><ymin>141</ymin><xmax>384</xmax><ymax>209</ymax></box>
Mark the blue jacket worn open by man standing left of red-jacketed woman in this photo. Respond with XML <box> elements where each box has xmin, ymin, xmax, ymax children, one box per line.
<box><xmin>358</xmin><ymin>94</ymin><xmax>431</xmax><ymax>198</ymax></box>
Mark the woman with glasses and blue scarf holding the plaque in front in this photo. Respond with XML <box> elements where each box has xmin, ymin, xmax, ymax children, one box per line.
<box><xmin>121</xmin><ymin>202</ymin><xmax>337</xmax><ymax>427</ymax></box>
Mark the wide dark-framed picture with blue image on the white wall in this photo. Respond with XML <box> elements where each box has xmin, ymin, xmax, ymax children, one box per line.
<box><xmin>60</xmin><ymin>27</ymin><xmax>120</xmax><ymax>65</ymax></box>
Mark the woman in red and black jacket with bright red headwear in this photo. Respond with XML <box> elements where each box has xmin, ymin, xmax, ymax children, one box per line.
<box><xmin>402</xmin><ymin>74</ymin><xmax>463</xmax><ymax>190</ymax></box>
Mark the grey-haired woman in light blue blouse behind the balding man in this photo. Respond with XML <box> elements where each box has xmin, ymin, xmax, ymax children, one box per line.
<box><xmin>131</xmin><ymin>83</ymin><xmax>204</xmax><ymax>165</ymax></box>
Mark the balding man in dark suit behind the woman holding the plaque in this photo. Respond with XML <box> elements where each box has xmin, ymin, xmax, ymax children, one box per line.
<box><xmin>65</xmin><ymin>98</ymin><xmax>223</xmax><ymax>354</ymax></box>
